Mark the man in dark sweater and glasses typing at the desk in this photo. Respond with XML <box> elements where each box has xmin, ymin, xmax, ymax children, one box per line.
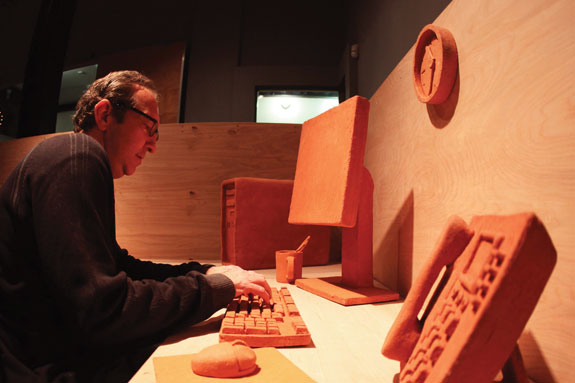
<box><xmin>0</xmin><ymin>71</ymin><xmax>270</xmax><ymax>382</ymax></box>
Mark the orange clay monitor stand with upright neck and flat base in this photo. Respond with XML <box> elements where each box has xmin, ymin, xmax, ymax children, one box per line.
<box><xmin>295</xmin><ymin>167</ymin><xmax>399</xmax><ymax>306</ymax></box>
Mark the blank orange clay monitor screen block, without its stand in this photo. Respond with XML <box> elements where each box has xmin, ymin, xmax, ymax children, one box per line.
<box><xmin>289</xmin><ymin>96</ymin><xmax>369</xmax><ymax>227</ymax></box>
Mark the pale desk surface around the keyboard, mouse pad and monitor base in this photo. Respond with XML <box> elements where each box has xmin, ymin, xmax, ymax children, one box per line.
<box><xmin>130</xmin><ymin>265</ymin><xmax>401</xmax><ymax>383</ymax></box>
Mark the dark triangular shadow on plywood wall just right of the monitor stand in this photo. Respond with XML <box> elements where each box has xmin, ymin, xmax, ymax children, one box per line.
<box><xmin>374</xmin><ymin>190</ymin><xmax>414</xmax><ymax>297</ymax></box>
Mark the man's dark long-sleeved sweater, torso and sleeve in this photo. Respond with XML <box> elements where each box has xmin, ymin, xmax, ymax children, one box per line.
<box><xmin>0</xmin><ymin>134</ymin><xmax>235</xmax><ymax>382</ymax></box>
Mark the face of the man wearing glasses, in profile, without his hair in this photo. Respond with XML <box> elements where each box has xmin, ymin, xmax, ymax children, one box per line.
<box><xmin>104</xmin><ymin>87</ymin><xmax>159</xmax><ymax>178</ymax></box>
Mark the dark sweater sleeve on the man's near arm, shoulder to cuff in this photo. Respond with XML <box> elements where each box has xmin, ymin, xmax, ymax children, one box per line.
<box><xmin>27</xmin><ymin>135</ymin><xmax>235</xmax><ymax>346</ymax></box>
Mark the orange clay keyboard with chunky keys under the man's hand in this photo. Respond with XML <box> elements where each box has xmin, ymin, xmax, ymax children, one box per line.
<box><xmin>220</xmin><ymin>287</ymin><xmax>311</xmax><ymax>347</ymax></box>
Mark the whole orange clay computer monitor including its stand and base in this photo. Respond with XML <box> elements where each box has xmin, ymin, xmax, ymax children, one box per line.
<box><xmin>288</xmin><ymin>96</ymin><xmax>399</xmax><ymax>306</ymax></box>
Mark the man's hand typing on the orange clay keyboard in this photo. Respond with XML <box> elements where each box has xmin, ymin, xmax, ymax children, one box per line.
<box><xmin>206</xmin><ymin>265</ymin><xmax>272</xmax><ymax>303</ymax></box>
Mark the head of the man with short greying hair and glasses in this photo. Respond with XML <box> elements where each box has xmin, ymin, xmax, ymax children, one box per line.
<box><xmin>74</xmin><ymin>71</ymin><xmax>159</xmax><ymax>178</ymax></box>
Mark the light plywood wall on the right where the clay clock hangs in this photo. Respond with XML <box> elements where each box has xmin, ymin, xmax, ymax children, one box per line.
<box><xmin>365</xmin><ymin>0</ymin><xmax>575</xmax><ymax>382</ymax></box>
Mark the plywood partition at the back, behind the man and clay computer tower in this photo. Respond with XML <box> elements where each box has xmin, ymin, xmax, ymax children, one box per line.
<box><xmin>116</xmin><ymin>123</ymin><xmax>301</xmax><ymax>261</ymax></box>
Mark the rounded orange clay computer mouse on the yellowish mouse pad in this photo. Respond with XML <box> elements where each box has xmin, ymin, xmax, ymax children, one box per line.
<box><xmin>192</xmin><ymin>340</ymin><xmax>257</xmax><ymax>378</ymax></box>
